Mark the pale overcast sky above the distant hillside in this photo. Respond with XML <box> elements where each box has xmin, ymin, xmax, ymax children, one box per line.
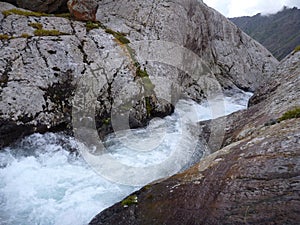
<box><xmin>203</xmin><ymin>0</ymin><xmax>300</xmax><ymax>17</ymax></box>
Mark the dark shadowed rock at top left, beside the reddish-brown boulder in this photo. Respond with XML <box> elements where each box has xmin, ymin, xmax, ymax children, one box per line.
<box><xmin>17</xmin><ymin>0</ymin><xmax>68</xmax><ymax>13</ymax></box>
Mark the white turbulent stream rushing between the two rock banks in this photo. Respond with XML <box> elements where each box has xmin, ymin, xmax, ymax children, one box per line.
<box><xmin>0</xmin><ymin>93</ymin><xmax>251</xmax><ymax>225</ymax></box>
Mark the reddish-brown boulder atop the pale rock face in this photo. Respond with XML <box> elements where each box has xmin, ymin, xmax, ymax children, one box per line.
<box><xmin>68</xmin><ymin>0</ymin><xmax>98</xmax><ymax>21</ymax></box>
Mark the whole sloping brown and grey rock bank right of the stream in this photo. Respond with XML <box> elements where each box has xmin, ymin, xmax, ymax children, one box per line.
<box><xmin>90</xmin><ymin>52</ymin><xmax>300</xmax><ymax>225</ymax></box>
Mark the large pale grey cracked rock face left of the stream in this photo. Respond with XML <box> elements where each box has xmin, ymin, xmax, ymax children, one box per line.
<box><xmin>0</xmin><ymin>0</ymin><xmax>277</xmax><ymax>147</ymax></box>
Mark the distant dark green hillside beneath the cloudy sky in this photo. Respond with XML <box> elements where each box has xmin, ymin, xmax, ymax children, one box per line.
<box><xmin>230</xmin><ymin>7</ymin><xmax>300</xmax><ymax>60</ymax></box>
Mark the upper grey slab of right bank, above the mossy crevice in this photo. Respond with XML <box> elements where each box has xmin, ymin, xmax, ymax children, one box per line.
<box><xmin>201</xmin><ymin>52</ymin><xmax>300</xmax><ymax>151</ymax></box>
